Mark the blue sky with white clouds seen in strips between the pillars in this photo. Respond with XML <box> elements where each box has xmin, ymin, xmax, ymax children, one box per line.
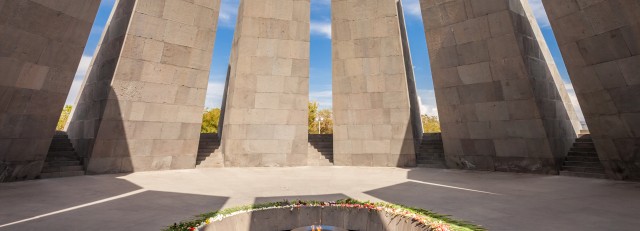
<box><xmin>67</xmin><ymin>0</ymin><xmax>583</xmax><ymax>119</ymax></box>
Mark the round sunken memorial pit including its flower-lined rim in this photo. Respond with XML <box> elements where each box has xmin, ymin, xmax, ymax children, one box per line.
<box><xmin>166</xmin><ymin>199</ymin><xmax>484</xmax><ymax>231</ymax></box>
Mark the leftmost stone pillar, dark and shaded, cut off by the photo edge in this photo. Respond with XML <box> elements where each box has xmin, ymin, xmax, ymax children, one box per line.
<box><xmin>0</xmin><ymin>0</ymin><xmax>100</xmax><ymax>182</ymax></box>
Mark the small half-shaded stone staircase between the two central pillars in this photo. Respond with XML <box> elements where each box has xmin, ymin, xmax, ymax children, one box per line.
<box><xmin>307</xmin><ymin>134</ymin><xmax>333</xmax><ymax>166</ymax></box>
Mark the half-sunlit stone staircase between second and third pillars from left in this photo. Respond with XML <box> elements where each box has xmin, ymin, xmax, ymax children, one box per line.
<box><xmin>196</xmin><ymin>133</ymin><xmax>224</xmax><ymax>168</ymax></box>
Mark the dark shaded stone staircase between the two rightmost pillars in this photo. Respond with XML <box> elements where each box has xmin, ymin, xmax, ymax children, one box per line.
<box><xmin>560</xmin><ymin>134</ymin><xmax>607</xmax><ymax>179</ymax></box>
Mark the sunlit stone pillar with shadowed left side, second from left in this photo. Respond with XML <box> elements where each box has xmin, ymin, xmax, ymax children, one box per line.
<box><xmin>68</xmin><ymin>0</ymin><xmax>220</xmax><ymax>174</ymax></box>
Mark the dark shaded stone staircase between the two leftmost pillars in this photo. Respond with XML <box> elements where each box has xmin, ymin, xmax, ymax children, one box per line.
<box><xmin>39</xmin><ymin>131</ymin><xmax>84</xmax><ymax>179</ymax></box>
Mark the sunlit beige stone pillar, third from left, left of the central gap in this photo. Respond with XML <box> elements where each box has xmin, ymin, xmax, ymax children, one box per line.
<box><xmin>221</xmin><ymin>0</ymin><xmax>310</xmax><ymax>167</ymax></box>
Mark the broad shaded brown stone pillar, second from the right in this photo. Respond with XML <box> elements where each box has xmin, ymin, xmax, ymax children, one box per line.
<box><xmin>420</xmin><ymin>0</ymin><xmax>579</xmax><ymax>174</ymax></box>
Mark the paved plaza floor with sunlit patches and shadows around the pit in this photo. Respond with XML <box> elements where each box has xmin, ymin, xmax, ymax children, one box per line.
<box><xmin>0</xmin><ymin>167</ymin><xmax>640</xmax><ymax>230</ymax></box>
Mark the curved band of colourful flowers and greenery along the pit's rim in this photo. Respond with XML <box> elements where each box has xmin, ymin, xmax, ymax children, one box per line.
<box><xmin>166</xmin><ymin>199</ymin><xmax>485</xmax><ymax>231</ymax></box>
